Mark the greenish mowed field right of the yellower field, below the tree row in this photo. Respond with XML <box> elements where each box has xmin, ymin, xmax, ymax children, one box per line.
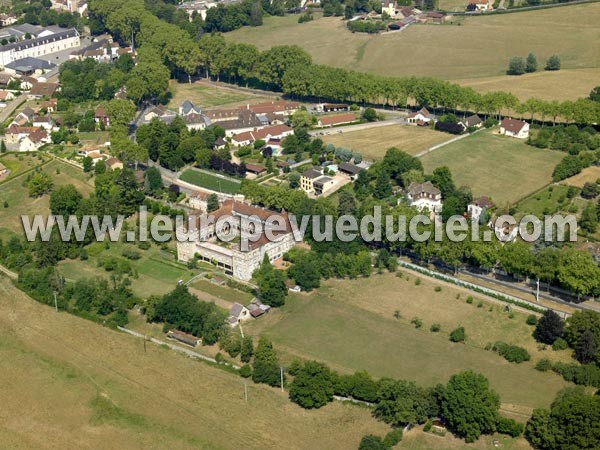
<box><xmin>421</xmin><ymin>130</ymin><xmax>565</xmax><ymax>206</ymax></box>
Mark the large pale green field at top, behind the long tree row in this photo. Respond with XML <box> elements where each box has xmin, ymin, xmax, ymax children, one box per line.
<box><xmin>226</xmin><ymin>3</ymin><xmax>600</xmax><ymax>96</ymax></box>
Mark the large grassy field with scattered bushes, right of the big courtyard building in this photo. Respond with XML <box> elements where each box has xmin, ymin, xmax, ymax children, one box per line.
<box><xmin>244</xmin><ymin>272</ymin><xmax>569</xmax><ymax>419</ymax></box>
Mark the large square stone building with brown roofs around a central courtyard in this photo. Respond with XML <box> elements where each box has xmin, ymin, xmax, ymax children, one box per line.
<box><xmin>177</xmin><ymin>200</ymin><xmax>295</xmax><ymax>280</ymax></box>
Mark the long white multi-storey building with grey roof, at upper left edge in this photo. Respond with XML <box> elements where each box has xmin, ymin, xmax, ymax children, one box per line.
<box><xmin>0</xmin><ymin>28</ymin><xmax>80</xmax><ymax>67</ymax></box>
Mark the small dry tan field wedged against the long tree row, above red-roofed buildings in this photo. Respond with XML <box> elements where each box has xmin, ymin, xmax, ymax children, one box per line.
<box><xmin>167</xmin><ymin>80</ymin><xmax>268</xmax><ymax>111</ymax></box>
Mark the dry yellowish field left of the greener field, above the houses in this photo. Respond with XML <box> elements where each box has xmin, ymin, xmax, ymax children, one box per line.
<box><xmin>321</xmin><ymin>125</ymin><xmax>452</xmax><ymax>160</ymax></box>
